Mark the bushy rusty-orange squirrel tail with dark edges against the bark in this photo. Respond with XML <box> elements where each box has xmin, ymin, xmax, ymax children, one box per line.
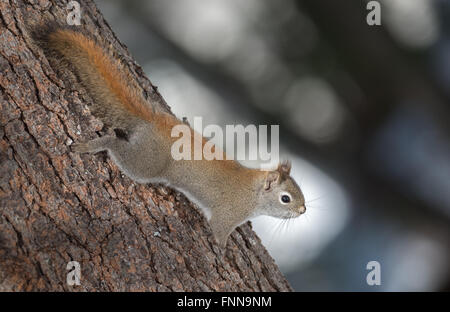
<box><xmin>34</xmin><ymin>26</ymin><xmax>154</xmax><ymax>129</ymax></box>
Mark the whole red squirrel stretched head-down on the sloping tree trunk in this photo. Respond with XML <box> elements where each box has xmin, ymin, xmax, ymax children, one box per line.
<box><xmin>36</xmin><ymin>27</ymin><xmax>306</xmax><ymax>248</ymax></box>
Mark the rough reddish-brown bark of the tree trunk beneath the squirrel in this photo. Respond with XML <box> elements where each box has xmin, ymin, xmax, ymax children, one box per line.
<box><xmin>0</xmin><ymin>0</ymin><xmax>291</xmax><ymax>291</ymax></box>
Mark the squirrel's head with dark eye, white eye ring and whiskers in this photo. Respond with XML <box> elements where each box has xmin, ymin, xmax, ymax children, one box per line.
<box><xmin>260</xmin><ymin>162</ymin><xmax>306</xmax><ymax>219</ymax></box>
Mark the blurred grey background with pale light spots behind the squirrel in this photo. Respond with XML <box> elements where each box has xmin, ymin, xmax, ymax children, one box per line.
<box><xmin>96</xmin><ymin>0</ymin><xmax>450</xmax><ymax>291</ymax></box>
